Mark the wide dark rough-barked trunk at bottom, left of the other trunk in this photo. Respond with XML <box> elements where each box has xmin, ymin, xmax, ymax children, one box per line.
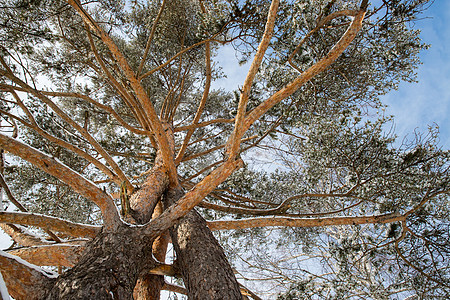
<box><xmin>47</xmin><ymin>226</ymin><xmax>155</xmax><ymax>300</ymax></box>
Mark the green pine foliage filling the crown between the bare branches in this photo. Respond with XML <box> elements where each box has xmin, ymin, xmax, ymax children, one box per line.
<box><xmin>0</xmin><ymin>0</ymin><xmax>450</xmax><ymax>299</ymax></box>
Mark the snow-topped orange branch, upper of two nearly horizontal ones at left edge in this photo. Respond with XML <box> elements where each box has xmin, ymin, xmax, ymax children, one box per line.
<box><xmin>0</xmin><ymin>211</ymin><xmax>101</xmax><ymax>238</ymax></box>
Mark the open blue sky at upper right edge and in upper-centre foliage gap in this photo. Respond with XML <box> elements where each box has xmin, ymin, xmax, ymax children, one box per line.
<box><xmin>213</xmin><ymin>0</ymin><xmax>450</xmax><ymax>149</ymax></box>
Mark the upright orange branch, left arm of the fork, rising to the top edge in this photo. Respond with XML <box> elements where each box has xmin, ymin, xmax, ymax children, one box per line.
<box><xmin>226</xmin><ymin>0</ymin><xmax>279</xmax><ymax>159</ymax></box>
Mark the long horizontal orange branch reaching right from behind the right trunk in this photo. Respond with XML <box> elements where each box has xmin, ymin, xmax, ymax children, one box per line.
<box><xmin>208</xmin><ymin>213</ymin><xmax>406</xmax><ymax>230</ymax></box>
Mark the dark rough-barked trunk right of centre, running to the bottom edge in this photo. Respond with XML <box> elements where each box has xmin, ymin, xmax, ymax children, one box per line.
<box><xmin>164</xmin><ymin>188</ymin><xmax>242</xmax><ymax>300</ymax></box>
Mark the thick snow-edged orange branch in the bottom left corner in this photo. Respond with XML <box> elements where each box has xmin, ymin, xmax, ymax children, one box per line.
<box><xmin>0</xmin><ymin>250</ymin><xmax>57</xmax><ymax>299</ymax></box>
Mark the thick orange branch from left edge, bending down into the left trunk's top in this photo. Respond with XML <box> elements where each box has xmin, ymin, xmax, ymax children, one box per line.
<box><xmin>0</xmin><ymin>134</ymin><xmax>121</xmax><ymax>229</ymax></box>
